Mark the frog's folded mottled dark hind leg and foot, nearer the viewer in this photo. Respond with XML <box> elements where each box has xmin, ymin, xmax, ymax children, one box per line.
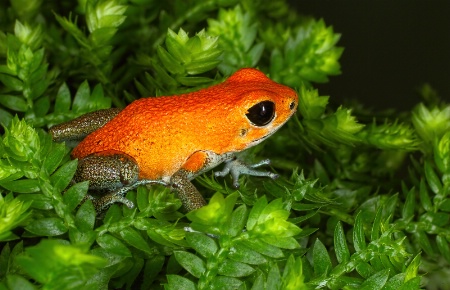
<box><xmin>73</xmin><ymin>152</ymin><xmax>167</xmax><ymax>212</ymax></box>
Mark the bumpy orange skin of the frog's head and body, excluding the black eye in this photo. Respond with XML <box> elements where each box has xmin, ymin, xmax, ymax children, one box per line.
<box><xmin>72</xmin><ymin>69</ymin><xmax>298</xmax><ymax>180</ymax></box>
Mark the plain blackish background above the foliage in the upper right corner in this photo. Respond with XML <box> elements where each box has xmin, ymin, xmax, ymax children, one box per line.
<box><xmin>290</xmin><ymin>0</ymin><xmax>450</xmax><ymax>110</ymax></box>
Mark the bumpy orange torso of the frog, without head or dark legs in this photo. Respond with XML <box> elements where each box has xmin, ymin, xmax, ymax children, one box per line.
<box><xmin>72</xmin><ymin>81</ymin><xmax>241</xmax><ymax>179</ymax></box>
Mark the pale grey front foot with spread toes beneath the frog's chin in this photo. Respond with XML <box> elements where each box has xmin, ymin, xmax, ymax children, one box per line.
<box><xmin>214</xmin><ymin>158</ymin><xmax>278</xmax><ymax>188</ymax></box>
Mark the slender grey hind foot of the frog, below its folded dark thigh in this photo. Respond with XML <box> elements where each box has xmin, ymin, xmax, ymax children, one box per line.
<box><xmin>86</xmin><ymin>179</ymin><xmax>167</xmax><ymax>213</ymax></box>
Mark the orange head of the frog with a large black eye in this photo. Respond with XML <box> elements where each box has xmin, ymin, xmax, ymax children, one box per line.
<box><xmin>227</xmin><ymin>69</ymin><xmax>298</xmax><ymax>149</ymax></box>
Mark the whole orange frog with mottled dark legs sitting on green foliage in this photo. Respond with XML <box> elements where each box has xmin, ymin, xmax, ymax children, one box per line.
<box><xmin>49</xmin><ymin>68</ymin><xmax>298</xmax><ymax>211</ymax></box>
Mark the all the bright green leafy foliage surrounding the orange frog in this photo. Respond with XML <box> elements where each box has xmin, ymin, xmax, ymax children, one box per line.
<box><xmin>0</xmin><ymin>0</ymin><xmax>450</xmax><ymax>289</ymax></box>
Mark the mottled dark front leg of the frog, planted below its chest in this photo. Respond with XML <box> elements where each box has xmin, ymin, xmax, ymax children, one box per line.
<box><xmin>170</xmin><ymin>169</ymin><xmax>206</xmax><ymax>212</ymax></box>
